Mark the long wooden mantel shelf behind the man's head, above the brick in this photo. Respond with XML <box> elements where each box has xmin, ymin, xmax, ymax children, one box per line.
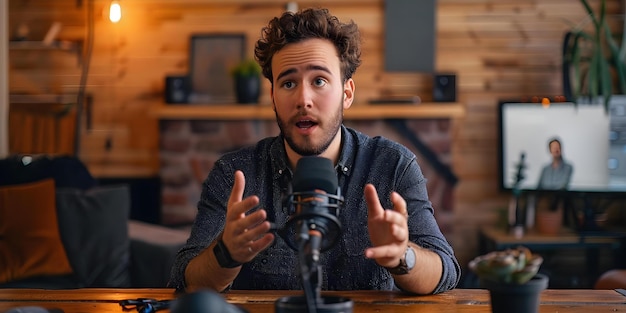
<box><xmin>150</xmin><ymin>102</ymin><xmax>465</xmax><ymax>120</ymax></box>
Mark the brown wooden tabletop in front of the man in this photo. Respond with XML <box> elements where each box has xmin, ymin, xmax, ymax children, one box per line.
<box><xmin>0</xmin><ymin>289</ymin><xmax>626</xmax><ymax>313</ymax></box>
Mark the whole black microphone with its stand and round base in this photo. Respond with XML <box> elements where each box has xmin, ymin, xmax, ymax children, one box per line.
<box><xmin>275</xmin><ymin>156</ymin><xmax>353</xmax><ymax>313</ymax></box>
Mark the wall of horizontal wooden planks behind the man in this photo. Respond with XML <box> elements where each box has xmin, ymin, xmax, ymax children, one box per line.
<box><xmin>9</xmin><ymin>0</ymin><xmax>623</xmax><ymax>270</ymax></box>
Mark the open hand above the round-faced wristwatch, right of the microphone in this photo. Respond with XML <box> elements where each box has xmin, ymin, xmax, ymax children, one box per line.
<box><xmin>365</xmin><ymin>184</ymin><xmax>409</xmax><ymax>267</ymax></box>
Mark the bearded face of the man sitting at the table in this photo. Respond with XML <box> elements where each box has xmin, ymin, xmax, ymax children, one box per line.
<box><xmin>272</xmin><ymin>39</ymin><xmax>354</xmax><ymax>156</ymax></box>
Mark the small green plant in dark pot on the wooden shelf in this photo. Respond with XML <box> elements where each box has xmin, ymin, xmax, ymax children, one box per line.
<box><xmin>231</xmin><ymin>59</ymin><xmax>261</xmax><ymax>103</ymax></box>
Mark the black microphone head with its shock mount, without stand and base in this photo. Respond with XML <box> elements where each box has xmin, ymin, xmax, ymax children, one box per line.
<box><xmin>281</xmin><ymin>156</ymin><xmax>343</xmax><ymax>254</ymax></box>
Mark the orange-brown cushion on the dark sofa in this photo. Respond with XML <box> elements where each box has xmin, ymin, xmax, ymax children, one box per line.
<box><xmin>0</xmin><ymin>179</ymin><xmax>72</xmax><ymax>283</ymax></box>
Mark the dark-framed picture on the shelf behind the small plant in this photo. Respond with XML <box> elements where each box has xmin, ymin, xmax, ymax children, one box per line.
<box><xmin>189</xmin><ymin>34</ymin><xmax>246</xmax><ymax>104</ymax></box>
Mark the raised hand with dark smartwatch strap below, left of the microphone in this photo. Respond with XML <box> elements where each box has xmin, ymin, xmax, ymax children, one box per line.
<box><xmin>222</xmin><ymin>171</ymin><xmax>274</xmax><ymax>263</ymax></box>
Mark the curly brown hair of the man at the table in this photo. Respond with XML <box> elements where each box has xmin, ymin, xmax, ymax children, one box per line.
<box><xmin>254</xmin><ymin>8</ymin><xmax>361</xmax><ymax>84</ymax></box>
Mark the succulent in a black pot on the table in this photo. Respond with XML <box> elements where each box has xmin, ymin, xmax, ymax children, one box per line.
<box><xmin>469</xmin><ymin>247</ymin><xmax>548</xmax><ymax>313</ymax></box>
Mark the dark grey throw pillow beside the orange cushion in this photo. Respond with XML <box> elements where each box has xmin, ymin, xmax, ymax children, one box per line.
<box><xmin>56</xmin><ymin>185</ymin><xmax>130</xmax><ymax>288</ymax></box>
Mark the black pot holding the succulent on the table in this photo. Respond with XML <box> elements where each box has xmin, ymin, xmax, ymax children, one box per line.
<box><xmin>480</xmin><ymin>274</ymin><xmax>548</xmax><ymax>313</ymax></box>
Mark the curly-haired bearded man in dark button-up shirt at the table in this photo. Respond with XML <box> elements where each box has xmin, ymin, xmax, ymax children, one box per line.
<box><xmin>168</xmin><ymin>8</ymin><xmax>460</xmax><ymax>294</ymax></box>
